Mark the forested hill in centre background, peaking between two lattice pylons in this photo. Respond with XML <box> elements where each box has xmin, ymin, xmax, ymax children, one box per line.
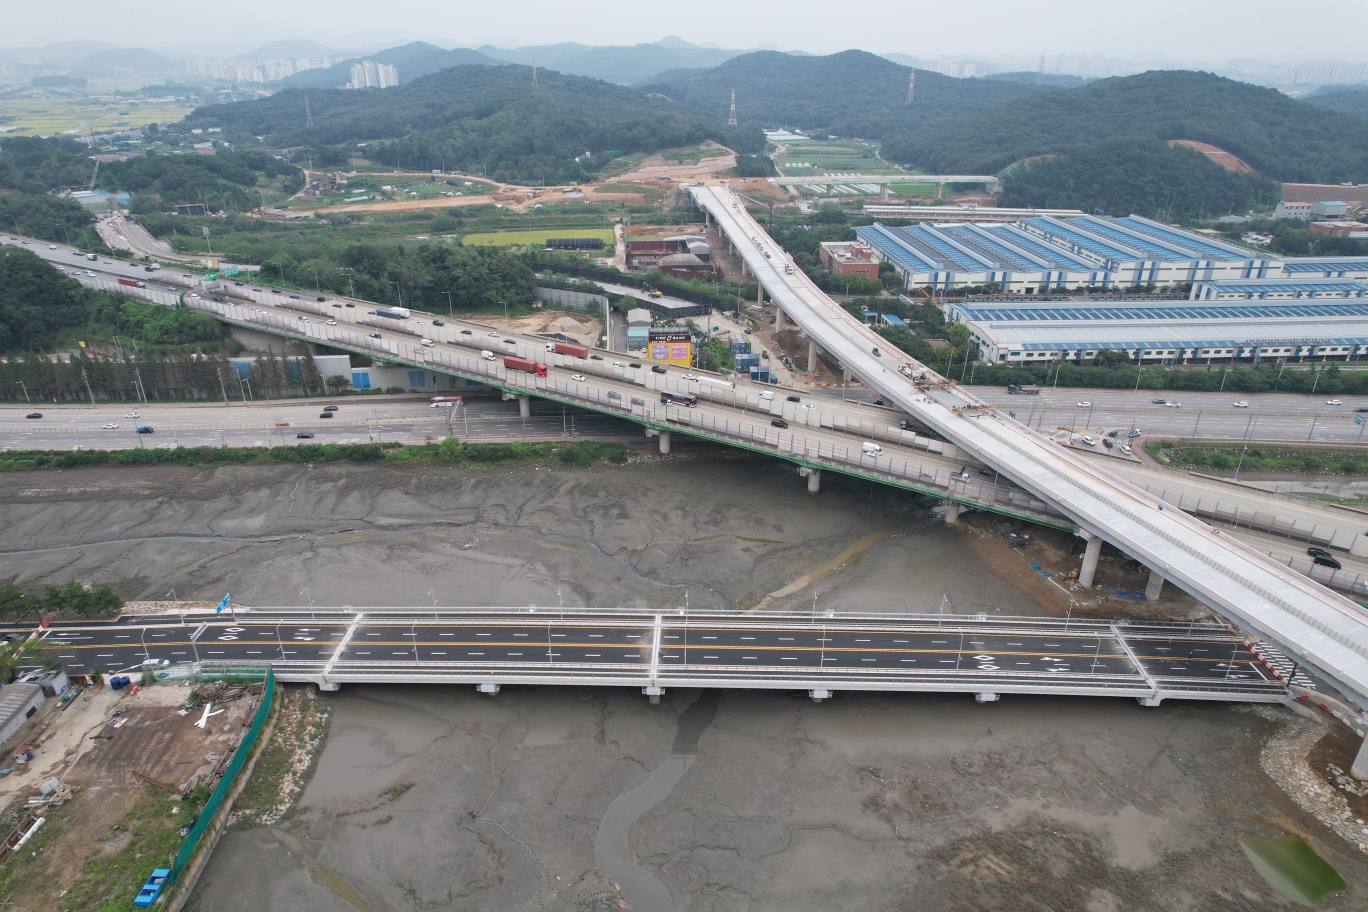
<box><xmin>637</xmin><ymin>51</ymin><xmax>1041</xmax><ymax>139</ymax></box>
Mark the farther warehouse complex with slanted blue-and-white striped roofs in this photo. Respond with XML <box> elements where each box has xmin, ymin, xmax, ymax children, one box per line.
<box><xmin>855</xmin><ymin>215</ymin><xmax>1368</xmax><ymax>294</ymax></box>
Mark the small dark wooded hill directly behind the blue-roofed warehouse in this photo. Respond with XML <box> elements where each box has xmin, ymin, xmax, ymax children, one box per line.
<box><xmin>1001</xmin><ymin>137</ymin><xmax>1280</xmax><ymax>219</ymax></box>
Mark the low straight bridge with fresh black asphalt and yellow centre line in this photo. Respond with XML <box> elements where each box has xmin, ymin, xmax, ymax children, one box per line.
<box><xmin>21</xmin><ymin>608</ymin><xmax>1291</xmax><ymax>704</ymax></box>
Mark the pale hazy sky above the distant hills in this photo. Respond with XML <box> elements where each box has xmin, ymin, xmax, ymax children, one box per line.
<box><xmin>8</xmin><ymin>0</ymin><xmax>1368</xmax><ymax>62</ymax></box>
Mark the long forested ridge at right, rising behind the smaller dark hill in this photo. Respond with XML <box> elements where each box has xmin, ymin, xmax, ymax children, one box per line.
<box><xmin>884</xmin><ymin>71</ymin><xmax>1368</xmax><ymax>183</ymax></box>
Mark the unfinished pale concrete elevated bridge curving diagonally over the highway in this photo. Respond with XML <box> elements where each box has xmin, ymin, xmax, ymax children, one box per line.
<box><xmin>689</xmin><ymin>185</ymin><xmax>1368</xmax><ymax>712</ymax></box>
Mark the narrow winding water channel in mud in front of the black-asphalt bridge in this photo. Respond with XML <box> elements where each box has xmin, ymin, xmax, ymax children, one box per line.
<box><xmin>594</xmin><ymin>690</ymin><xmax>722</xmax><ymax>912</ymax></box>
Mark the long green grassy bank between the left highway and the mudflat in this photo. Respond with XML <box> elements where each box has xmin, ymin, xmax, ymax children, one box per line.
<box><xmin>0</xmin><ymin>438</ymin><xmax>628</xmax><ymax>472</ymax></box>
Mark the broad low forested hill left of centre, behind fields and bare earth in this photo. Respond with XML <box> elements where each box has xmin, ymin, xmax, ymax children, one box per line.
<box><xmin>185</xmin><ymin>66</ymin><xmax>765</xmax><ymax>183</ymax></box>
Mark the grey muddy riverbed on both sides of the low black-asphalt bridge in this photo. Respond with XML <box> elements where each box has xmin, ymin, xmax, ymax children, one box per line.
<box><xmin>0</xmin><ymin>459</ymin><xmax>1368</xmax><ymax>912</ymax></box>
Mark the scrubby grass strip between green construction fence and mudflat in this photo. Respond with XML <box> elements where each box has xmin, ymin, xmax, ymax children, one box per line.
<box><xmin>233</xmin><ymin>685</ymin><xmax>332</xmax><ymax>826</ymax></box>
